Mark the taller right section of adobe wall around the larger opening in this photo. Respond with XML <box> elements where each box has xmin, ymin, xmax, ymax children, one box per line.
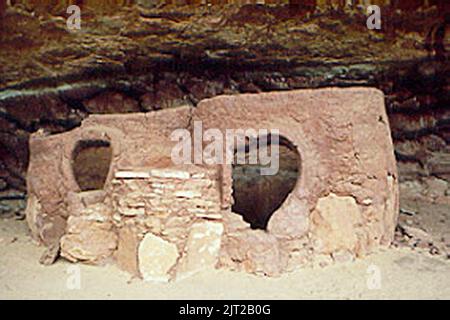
<box><xmin>193</xmin><ymin>88</ymin><xmax>399</xmax><ymax>275</ymax></box>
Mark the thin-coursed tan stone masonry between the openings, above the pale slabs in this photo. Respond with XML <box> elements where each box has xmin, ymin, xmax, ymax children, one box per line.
<box><xmin>110</xmin><ymin>168</ymin><xmax>221</xmax><ymax>250</ymax></box>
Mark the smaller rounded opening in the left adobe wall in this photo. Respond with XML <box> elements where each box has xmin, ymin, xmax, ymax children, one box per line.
<box><xmin>72</xmin><ymin>140</ymin><xmax>112</xmax><ymax>191</ymax></box>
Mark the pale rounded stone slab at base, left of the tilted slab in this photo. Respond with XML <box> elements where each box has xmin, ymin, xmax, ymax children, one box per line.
<box><xmin>138</xmin><ymin>233</ymin><xmax>179</xmax><ymax>281</ymax></box>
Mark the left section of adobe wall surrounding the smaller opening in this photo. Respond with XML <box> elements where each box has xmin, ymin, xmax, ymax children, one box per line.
<box><xmin>26</xmin><ymin>107</ymin><xmax>190</xmax><ymax>245</ymax></box>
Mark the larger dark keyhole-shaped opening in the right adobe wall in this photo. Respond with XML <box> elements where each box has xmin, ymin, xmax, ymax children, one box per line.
<box><xmin>232</xmin><ymin>136</ymin><xmax>301</xmax><ymax>230</ymax></box>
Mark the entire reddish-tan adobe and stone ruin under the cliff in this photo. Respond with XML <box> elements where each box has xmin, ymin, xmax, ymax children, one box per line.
<box><xmin>27</xmin><ymin>88</ymin><xmax>398</xmax><ymax>281</ymax></box>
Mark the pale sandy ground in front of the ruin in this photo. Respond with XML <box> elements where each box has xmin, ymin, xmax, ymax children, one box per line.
<box><xmin>0</xmin><ymin>219</ymin><xmax>450</xmax><ymax>299</ymax></box>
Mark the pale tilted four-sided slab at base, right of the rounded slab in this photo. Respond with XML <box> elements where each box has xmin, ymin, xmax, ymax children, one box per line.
<box><xmin>177</xmin><ymin>221</ymin><xmax>223</xmax><ymax>279</ymax></box>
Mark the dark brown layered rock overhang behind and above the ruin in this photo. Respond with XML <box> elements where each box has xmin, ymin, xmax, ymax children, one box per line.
<box><xmin>0</xmin><ymin>1</ymin><xmax>450</xmax><ymax>215</ymax></box>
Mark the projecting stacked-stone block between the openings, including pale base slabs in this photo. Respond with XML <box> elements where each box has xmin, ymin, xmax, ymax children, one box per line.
<box><xmin>61</xmin><ymin>167</ymin><xmax>223</xmax><ymax>281</ymax></box>
